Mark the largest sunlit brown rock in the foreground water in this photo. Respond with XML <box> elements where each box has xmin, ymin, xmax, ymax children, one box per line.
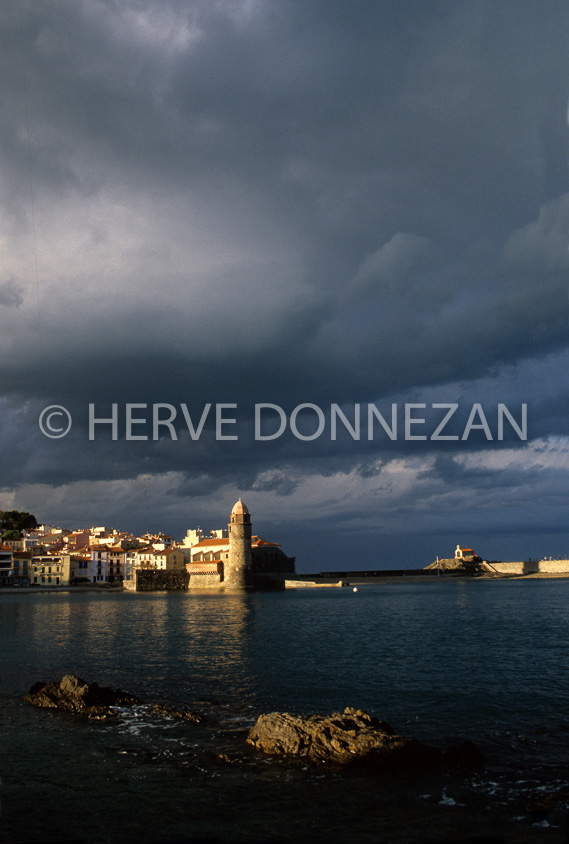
<box><xmin>247</xmin><ymin>708</ymin><xmax>442</xmax><ymax>773</ymax></box>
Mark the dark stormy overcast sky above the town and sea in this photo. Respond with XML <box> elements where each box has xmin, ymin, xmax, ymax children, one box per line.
<box><xmin>0</xmin><ymin>0</ymin><xmax>569</xmax><ymax>571</ymax></box>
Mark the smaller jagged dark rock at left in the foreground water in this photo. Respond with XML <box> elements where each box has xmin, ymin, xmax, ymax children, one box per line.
<box><xmin>24</xmin><ymin>674</ymin><xmax>140</xmax><ymax>718</ymax></box>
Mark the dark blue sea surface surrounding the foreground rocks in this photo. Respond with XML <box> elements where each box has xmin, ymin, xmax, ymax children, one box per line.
<box><xmin>0</xmin><ymin>579</ymin><xmax>569</xmax><ymax>844</ymax></box>
